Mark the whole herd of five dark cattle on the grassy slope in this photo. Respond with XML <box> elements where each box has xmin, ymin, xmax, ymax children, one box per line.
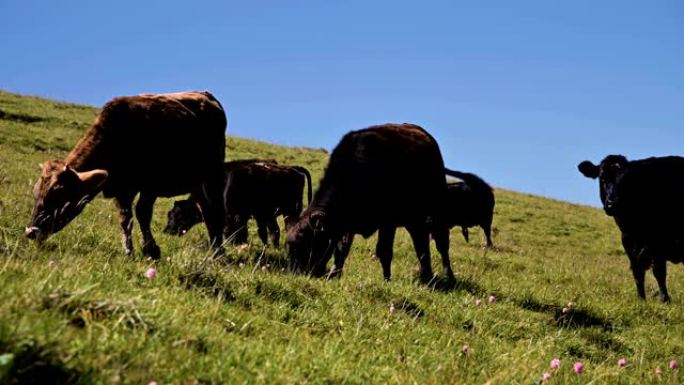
<box><xmin>21</xmin><ymin>92</ymin><xmax>684</xmax><ymax>301</ymax></box>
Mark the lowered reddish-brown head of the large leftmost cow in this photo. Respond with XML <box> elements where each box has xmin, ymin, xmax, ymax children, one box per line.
<box><xmin>26</xmin><ymin>160</ymin><xmax>107</xmax><ymax>243</ymax></box>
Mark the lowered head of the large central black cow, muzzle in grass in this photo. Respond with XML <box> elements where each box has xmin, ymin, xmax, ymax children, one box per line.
<box><xmin>286</xmin><ymin>210</ymin><xmax>331</xmax><ymax>277</ymax></box>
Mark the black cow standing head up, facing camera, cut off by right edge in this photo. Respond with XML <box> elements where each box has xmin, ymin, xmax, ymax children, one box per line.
<box><xmin>578</xmin><ymin>155</ymin><xmax>684</xmax><ymax>301</ymax></box>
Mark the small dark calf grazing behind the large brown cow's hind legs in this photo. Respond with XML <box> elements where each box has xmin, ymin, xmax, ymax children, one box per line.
<box><xmin>164</xmin><ymin>159</ymin><xmax>311</xmax><ymax>247</ymax></box>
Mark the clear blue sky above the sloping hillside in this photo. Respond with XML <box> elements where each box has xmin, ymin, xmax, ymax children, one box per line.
<box><xmin>0</xmin><ymin>0</ymin><xmax>684</xmax><ymax>205</ymax></box>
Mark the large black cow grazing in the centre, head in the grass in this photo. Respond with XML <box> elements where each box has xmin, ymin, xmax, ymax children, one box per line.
<box><xmin>287</xmin><ymin>124</ymin><xmax>453</xmax><ymax>282</ymax></box>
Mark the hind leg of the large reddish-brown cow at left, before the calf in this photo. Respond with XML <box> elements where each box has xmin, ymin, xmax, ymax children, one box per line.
<box><xmin>197</xmin><ymin>172</ymin><xmax>226</xmax><ymax>254</ymax></box>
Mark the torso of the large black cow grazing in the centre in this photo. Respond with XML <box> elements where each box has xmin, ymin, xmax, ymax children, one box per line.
<box><xmin>312</xmin><ymin>124</ymin><xmax>446</xmax><ymax>235</ymax></box>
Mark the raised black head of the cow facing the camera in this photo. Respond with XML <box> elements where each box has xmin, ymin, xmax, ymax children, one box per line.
<box><xmin>577</xmin><ymin>155</ymin><xmax>629</xmax><ymax>216</ymax></box>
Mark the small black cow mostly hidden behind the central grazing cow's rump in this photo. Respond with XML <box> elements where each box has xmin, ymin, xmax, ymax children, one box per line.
<box><xmin>446</xmin><ymin>171</ymin><xmax>494</xmax><ymax>248</ymax></box>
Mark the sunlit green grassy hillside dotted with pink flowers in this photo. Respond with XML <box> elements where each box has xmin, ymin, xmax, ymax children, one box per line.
<box><xmin>0</xmin><ymin>92</ymin><xmax>684</xmax><ymax>384</ymax></box>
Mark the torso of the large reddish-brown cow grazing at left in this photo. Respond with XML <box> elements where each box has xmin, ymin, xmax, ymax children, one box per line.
<box><xmin>75</xmin><ymin>92</ymin><xmax>226</xmax><ymax>196</ymax></box>
